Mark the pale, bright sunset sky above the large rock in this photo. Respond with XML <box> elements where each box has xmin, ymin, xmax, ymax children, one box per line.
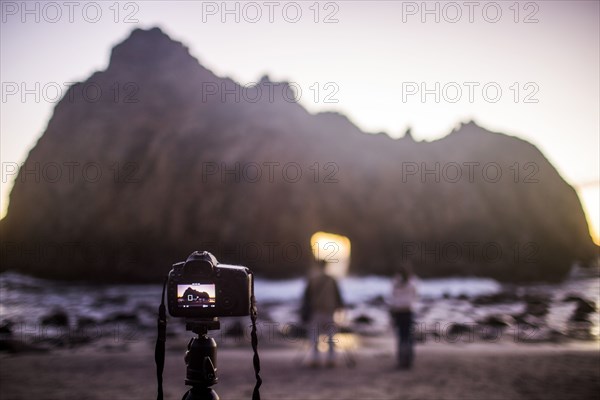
<box><xmin>0</xmin><ymin>0</ymin><xmax>600</xmax><ymax>242</ymax></box>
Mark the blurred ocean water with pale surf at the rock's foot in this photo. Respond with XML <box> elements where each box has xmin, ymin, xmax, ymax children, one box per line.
<box><xmin>0</xmin><ymin>272</ymin><xmax>600</xmax><ymax>344</ymax></box>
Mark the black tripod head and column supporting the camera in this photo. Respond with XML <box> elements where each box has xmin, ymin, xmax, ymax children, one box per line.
<box><xmin>182</xmin><ymin>318</ymin><xmax>221</xmax><ymax>400</ymax></box>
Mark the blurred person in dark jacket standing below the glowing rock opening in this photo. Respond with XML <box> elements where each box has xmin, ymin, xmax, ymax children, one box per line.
<box><xmin>301</xmin><ymin>260</ymin><xmax>343</xmax><ymax>368</ymax></box>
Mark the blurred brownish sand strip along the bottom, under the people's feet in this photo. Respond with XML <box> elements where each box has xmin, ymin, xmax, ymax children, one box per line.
<box><xmin>0</xmin><ymin>336</ymin><xmax>600</xmax><ymax>400</ymax></box>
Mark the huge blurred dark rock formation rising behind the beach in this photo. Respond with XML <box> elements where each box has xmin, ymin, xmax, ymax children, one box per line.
<box><xmin>2</xmin><ymin>29</ymin><xmax>597</xmax><ymax>281</ymax></box>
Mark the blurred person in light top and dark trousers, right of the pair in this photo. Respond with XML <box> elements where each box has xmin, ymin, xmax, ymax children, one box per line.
<box><xmin>390</xmin><ymin>265</ymin><xmax>417</xmax><ymax>369</ymax></box>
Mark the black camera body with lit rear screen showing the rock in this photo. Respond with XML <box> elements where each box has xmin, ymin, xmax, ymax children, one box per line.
<box><xmin>167</xmin><ymin>251</ymin><xmax>253</xmax><ymax>318</ymax></box>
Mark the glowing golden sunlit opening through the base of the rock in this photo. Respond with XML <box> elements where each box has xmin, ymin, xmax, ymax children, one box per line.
<box><xmin>310</xmin><ymin>232</ymin><xmax>351</xmax><ymax>278</ymax></box>
